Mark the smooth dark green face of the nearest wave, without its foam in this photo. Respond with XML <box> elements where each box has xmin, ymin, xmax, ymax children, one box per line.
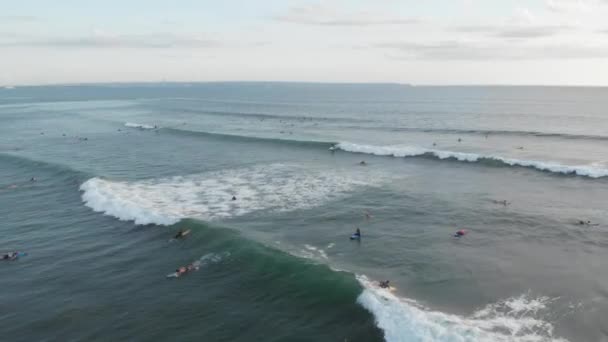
<box><xmin>162</xmin><ymin>219</ymin><xmax>382</xmax><ymax>341</ymax></box>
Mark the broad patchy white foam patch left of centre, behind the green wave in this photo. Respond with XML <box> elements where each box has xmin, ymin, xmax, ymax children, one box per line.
<box><xmin>80</xmin><ymin>164</ymin><xmax>371</xmax><ymax>225</ymax></box>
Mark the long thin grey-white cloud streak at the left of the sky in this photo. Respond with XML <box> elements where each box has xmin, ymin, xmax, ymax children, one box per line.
<box><xmin>0</xmin><ymin>30</ymin><xmax>220</xmax><ymax>49</ymax></box>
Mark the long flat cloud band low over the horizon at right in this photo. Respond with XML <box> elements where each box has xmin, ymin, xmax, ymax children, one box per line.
<box><xmin>375</xmin><ymin>40</ymin><xmax>608</xmax><ymax>61</ymax></box>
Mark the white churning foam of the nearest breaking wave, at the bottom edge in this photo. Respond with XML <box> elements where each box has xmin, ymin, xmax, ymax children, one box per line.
<box><xmin>357</xmin><ymin>276</ymin><xmax>566</xmax><ymax>342</ymax></box>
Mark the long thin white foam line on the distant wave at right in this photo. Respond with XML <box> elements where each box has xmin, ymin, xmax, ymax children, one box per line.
<box><xmin>332</xmin><ymin>142</ymin><xmax>608</xmax><ymax>178</ymax></box>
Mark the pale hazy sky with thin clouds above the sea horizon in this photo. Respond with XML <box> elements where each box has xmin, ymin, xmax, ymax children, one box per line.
<box><xmin>0</xmin><ymin>0</ymin><xmax>608</xmax><ymax>86</ymax></box>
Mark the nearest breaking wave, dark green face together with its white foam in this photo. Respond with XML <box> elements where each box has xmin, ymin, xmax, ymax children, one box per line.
<box><xmin>128</xmin><ymin>219</ymin><xmax>564</xmax><ymax>342</ymax></box>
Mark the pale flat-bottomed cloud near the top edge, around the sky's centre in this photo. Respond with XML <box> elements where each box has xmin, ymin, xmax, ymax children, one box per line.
<box><xmin>274</xmin><ymin>5</ymin><xmax>421</xmax><ymax>26</ymax></box>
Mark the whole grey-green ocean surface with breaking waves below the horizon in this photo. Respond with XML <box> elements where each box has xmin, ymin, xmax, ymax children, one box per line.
<box><xmin>0</xmin><ymin>83</ymin><xmax>608</xmax><ymax>342</ymax></box>
